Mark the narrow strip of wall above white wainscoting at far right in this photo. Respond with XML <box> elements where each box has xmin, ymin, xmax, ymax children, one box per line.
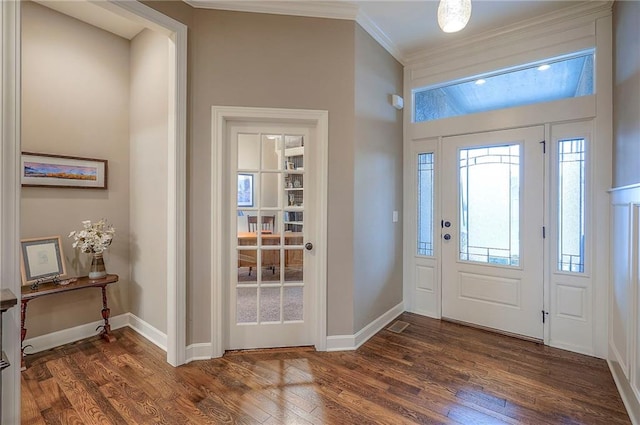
<box><xmin>613</xmin><ymin>1</ymin><xmax>640</xmax><ymax>186</ymax></box>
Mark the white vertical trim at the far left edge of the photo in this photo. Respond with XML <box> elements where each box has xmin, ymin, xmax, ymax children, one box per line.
<box><xmin>0</xmin><ymin>1</ymin><xmax>21</xmax><ymax>424</ymax></box>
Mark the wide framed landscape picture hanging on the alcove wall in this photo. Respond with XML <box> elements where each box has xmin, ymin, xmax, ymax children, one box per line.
<box><xmin>20</xmin><ymin>152</ymin><xmax>108</xmax><ymax>189</ymax></box>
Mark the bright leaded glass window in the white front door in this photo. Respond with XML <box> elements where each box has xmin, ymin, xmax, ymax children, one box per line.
<box><xmin>459</xmin><ymin>144</ymin><xmax>520</xmax><ymax>266</ymax></box>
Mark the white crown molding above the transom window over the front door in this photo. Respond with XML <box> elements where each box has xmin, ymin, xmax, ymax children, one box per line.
<box><xmin>404</xmin><ymin>0</ymin><xmax>613</xmax><ymax>66</ymax></box>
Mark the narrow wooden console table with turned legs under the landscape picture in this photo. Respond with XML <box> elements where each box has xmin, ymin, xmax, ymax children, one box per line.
<box><xmin>20</xmin><ymin>274</ymin><xmax>118</xmax><ymax>370</ymax></box>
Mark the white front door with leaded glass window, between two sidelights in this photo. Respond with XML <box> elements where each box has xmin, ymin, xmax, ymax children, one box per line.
<box><xmin>438</xmin><ymin>126</ymin><xmax>544</xmax><ymax>339</ymax></box>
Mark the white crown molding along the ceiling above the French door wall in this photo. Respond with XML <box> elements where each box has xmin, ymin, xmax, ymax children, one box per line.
<box><xmin>184</xmin><ymin>0</ymin><xmax>358</xmax><ymax>20</ymax></box>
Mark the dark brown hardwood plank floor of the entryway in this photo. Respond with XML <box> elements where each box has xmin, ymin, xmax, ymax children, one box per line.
<box><xmin>22</xmin><ymin>313</ymin><xmax>631</xmax><ymax>425</ymax></box>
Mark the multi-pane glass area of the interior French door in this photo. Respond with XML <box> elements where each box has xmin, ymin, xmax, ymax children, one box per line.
<box><xmin>235</xmin><ymin>133</ymin><xmax>305</xmax><ymax>325</ymax></box>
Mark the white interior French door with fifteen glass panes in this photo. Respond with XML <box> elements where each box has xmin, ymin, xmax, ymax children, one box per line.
<box><xmin>226</xmin><ymin>123</ymin><xmax>319</xmax><ymax>349</ymax></box>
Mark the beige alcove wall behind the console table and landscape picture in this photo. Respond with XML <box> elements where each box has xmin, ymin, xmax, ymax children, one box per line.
<box><xmin>21</xmin><ymin>2</ymin><xmax>129</xmax><ymax>338</ymax></box>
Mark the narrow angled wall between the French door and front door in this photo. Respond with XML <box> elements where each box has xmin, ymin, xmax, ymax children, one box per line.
<box><xmin>353</xmin><ymin>26</ymin><xmax>403</xmax><ymax>332</ymax></box>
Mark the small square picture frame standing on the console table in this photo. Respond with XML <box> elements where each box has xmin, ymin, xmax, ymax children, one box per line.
<box><xmin>20</xmin><ymin>236</ymin><xmax>67</xmax><ymax>286</ymax></box>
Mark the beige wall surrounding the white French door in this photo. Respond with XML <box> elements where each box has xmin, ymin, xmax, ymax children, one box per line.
<box><xmin>145</xmin><ymin>1</ymin><xmax>356</xmax><ymax>344</ymax></box>
